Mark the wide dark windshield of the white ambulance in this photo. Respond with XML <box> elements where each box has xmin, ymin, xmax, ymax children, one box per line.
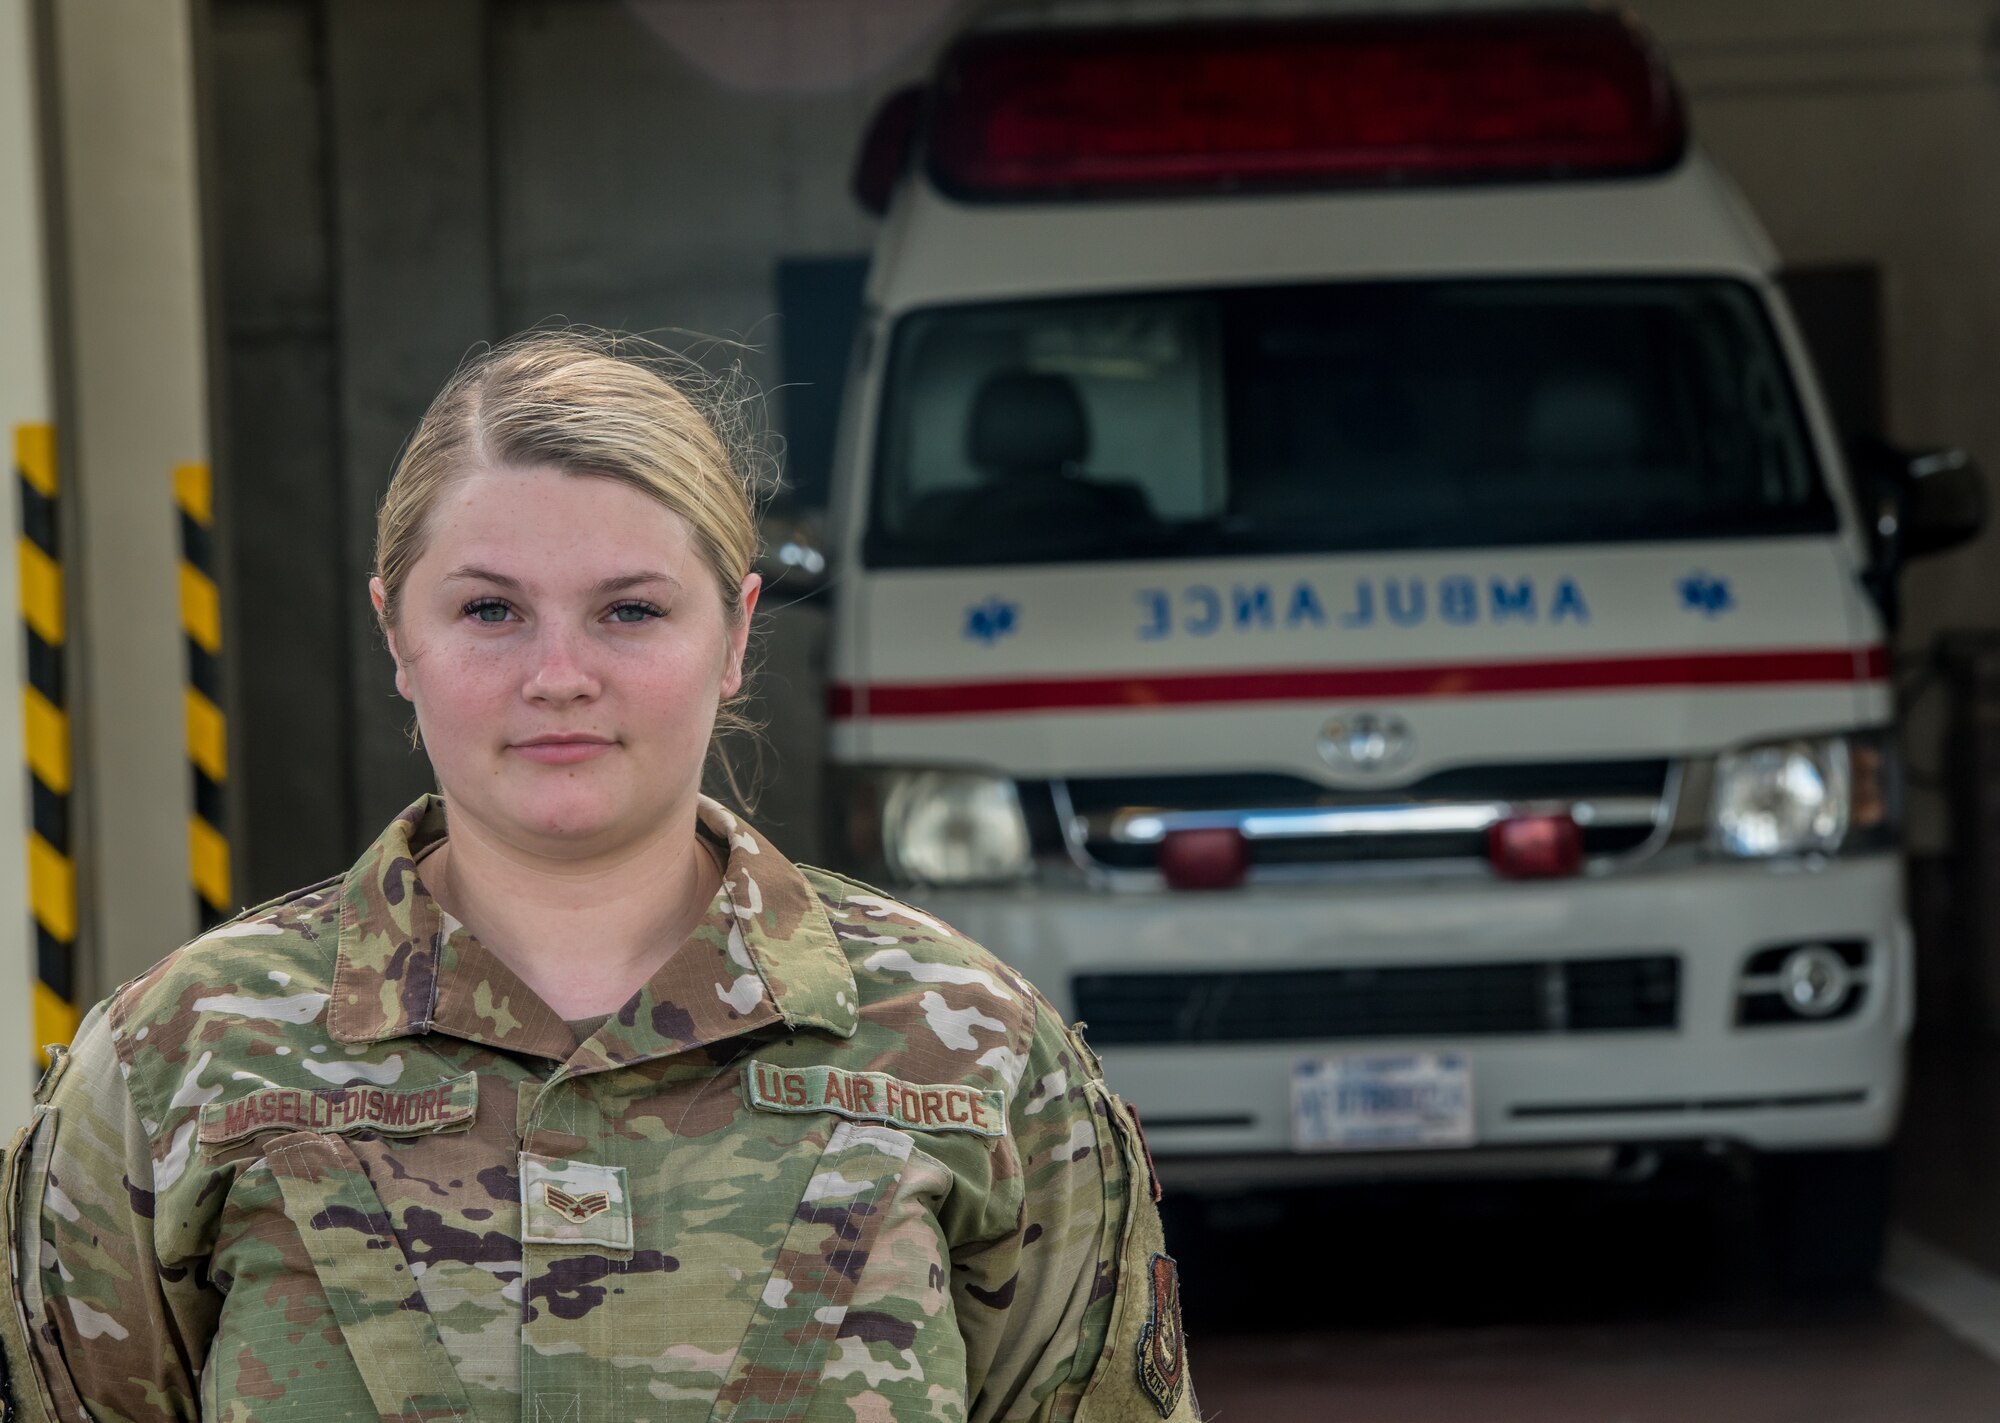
<box><xmin>864</xmin><ymin>280</ymin><xmax>1836</xmax><ymax>568</ymax></box>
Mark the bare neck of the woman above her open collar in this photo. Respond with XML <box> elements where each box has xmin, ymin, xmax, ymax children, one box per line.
<box><xmin>422</xmin><ymin>803</ymin><xmax>722</xmax><ymax>1019</ymax></box>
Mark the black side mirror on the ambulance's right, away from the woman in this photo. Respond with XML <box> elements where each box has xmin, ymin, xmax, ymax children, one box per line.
<box><xmin>1848</xmin><ymin>436</ymin><xmax>1986</xmax><ymax>626</ymax></box>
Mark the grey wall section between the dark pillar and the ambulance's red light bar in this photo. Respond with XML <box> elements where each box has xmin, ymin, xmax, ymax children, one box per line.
<box><xmin>492</xmin><ymin>0</ymin><xmax>954</xmax><ymax>427</ymax></box>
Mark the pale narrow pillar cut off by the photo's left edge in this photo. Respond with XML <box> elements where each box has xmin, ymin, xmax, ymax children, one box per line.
<box><xmin>0</xmin><ymin>0</ymin><xmax>54</xmax><ymax>1133</ymax></box>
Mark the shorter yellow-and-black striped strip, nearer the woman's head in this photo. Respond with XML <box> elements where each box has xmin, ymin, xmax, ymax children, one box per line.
<box><xmin>174</xmin><ymin>464</ymin><xmax>230</xmax><ymax>929</ymax></box>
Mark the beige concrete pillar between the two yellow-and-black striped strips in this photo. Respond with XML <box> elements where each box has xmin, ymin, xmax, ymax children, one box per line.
<box><xmin>46</xmin><ymin>0</ymin><xmax>208</xmax><ymax>991</ymax></box>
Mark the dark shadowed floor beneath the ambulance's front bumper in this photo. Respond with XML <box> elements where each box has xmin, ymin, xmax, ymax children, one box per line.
<box><xmin>1176</xmin><ymin>1193</ymin><xmax>2000</xmax><ymax>1423</ymax></box>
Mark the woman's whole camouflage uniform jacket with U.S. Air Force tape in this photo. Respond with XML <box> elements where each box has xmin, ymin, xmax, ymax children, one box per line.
<box><xmin>0</xmin><ymin>799</ymin><xmax>1194</xmax><ymax>1423</ymax></box>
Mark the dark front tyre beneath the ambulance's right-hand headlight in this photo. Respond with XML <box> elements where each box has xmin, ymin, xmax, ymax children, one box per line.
<box><xmin>1758</xmin><ymin>1147</ymin><xmax>1890</xmax><ymax>1293</ymax></box>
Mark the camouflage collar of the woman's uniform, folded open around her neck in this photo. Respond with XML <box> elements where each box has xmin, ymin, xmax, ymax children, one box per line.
<box><xmin>326</xmin><ymin>795</ymin><xmax>858</xmax><ymax>1071</ymax></box>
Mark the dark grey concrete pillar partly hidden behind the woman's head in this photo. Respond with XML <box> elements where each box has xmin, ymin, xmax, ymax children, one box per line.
<box><xmin>324</xmin><ymin>0</ymin><xmax>500</xmax><ymax>827</ymax></box>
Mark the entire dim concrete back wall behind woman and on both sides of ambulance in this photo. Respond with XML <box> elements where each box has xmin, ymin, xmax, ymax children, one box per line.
<box><xmin>214</xmin><ymin>0</ymin><xmax>2000</xmax><ymax>891</ymax></box>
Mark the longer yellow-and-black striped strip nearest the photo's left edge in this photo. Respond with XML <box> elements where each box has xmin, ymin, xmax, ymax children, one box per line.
<box><xmin>14</xmin><ymin>424</ymin><xmax>80</xmax><ymax>1061</ymax></box>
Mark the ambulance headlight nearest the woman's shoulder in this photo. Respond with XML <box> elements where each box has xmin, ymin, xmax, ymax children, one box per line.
<box><xmin>882</xmin><ymin>771</ymin><xmax>1034</xmax><ymax>885</ymax></box>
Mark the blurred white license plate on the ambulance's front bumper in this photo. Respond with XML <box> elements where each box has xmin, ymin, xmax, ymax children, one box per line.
<box><xmin>1292</xmin><ymin>1053</ymin><xmax>1472</xmax><ymax>1151</ymax></box>
